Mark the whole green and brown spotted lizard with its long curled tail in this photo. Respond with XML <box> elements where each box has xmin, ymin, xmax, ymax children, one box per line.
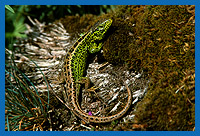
<box><xmin>63</xmin><ymin>19</ymin><xmax>132</xmax><ymax>123</ymax></box>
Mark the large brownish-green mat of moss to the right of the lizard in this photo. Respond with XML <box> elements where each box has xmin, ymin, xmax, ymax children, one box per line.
<box><xmin>104</xmin><ymin>6</ymin><xmax>195</xmax><ymax>130</ymax></box>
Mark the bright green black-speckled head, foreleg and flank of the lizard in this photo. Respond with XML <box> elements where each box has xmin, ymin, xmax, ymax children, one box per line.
<box><xmin>69</xmin><ymin>19</ymin><xmax>112</xmax><ymax>81</ymax></box>
